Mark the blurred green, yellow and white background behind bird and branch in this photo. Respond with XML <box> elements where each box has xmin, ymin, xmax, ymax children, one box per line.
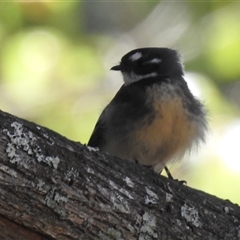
<box><xmin>0</xmin><ymin>0</ymin><xmax>240</xmax><ymax>204</ymax></box>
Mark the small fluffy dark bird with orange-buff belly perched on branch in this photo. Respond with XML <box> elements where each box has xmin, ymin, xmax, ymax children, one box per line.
<box><xmin>88</xmin><ymin>48</ymin><xmax>207</xmax><ymax>177</ymax></box>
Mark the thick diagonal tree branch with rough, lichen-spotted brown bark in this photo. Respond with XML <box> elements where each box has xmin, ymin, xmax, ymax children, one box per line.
<box><xmin>0</xmin><ymin>109</ymin><xmax>240</xmax><ymax>240</ymax></box>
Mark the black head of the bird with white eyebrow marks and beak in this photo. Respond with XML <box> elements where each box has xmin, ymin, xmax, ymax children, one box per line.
<box><xmin>111</xmin><ymin>48</ymin><xmax>183</xmax><ymax>85</ymax></box>
